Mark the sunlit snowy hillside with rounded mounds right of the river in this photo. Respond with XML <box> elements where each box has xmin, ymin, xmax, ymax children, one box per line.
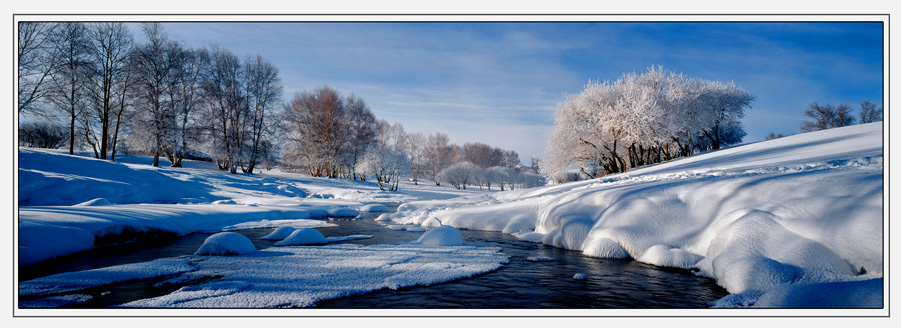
<box><xmin>383</xmin><ymin>122</ymin><xmax>886</xmax><ymax>308</ymax></box>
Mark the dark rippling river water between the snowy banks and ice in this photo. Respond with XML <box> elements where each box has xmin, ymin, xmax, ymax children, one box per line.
<box><xmin>19</xmin><ymin>209</ymin><xmax>727</xmax><ymax>309</ymax></box>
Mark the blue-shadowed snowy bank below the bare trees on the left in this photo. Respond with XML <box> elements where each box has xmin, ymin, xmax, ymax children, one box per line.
<box><xmin>16</xmin><ymin>148</ymin><xmax>475</xmax><ymax>266</ymax></box>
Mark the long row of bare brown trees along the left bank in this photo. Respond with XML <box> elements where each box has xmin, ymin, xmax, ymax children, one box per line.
<box><xmin>18</xmin><ymin>22</ymin><xmax>526</xmax><ymax>190</ymax></box>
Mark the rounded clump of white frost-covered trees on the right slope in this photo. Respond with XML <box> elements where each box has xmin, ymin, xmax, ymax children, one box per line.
<box><xmin>541</xmin><ymin>67</ymin><xmax>754</xmax><ymax>183</ymax></box>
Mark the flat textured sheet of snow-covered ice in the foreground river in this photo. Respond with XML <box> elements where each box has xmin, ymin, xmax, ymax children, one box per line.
<box><xmin>113</xmin><ymin>243</ymin><xmax>508</xmax><ymax>308</ymax></box>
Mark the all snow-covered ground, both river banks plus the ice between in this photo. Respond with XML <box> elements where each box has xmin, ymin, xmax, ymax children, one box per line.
<box><xmin>16</xmin><ymin>123</ymin><xmax>887</xmax><ymax>308</ymax></box>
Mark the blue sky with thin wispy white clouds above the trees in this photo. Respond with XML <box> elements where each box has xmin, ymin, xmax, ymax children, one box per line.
<box><xmin>153</xmin><ymin>22</ymin><xmax>883</xmax><ymax>162</ymax></box>
